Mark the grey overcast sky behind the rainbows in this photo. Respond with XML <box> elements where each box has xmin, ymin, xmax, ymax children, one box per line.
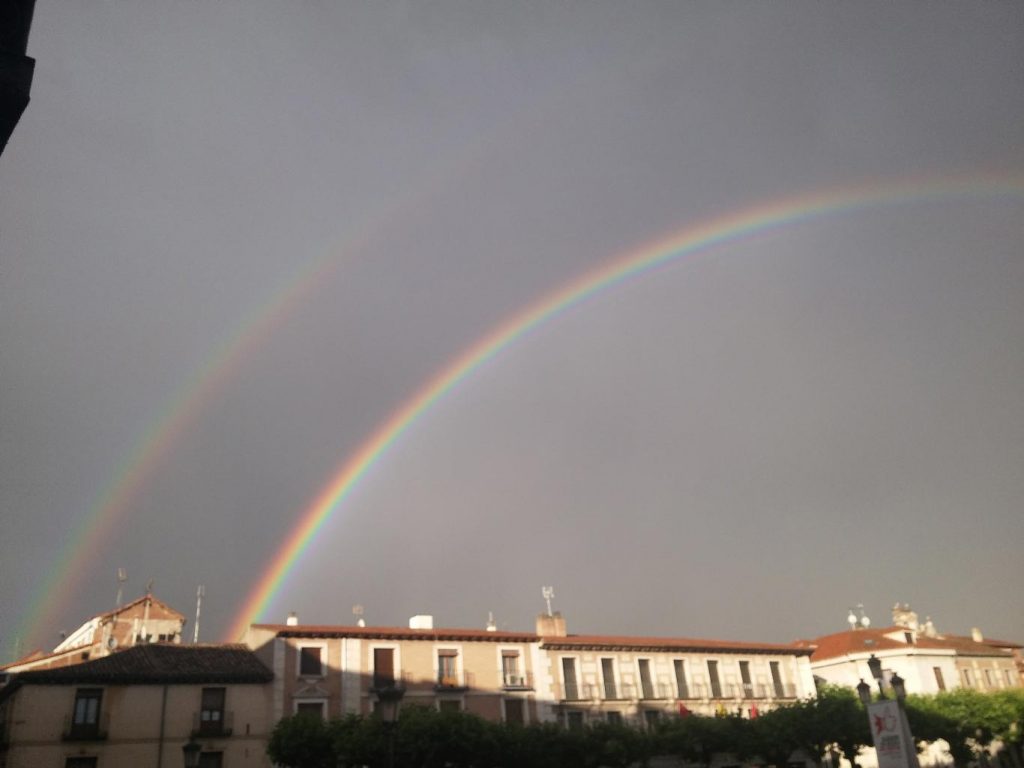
<box><xmin>0</xmin><ymin>0</ymin><xmax>1024</xmax><ymax>658</ymax></box>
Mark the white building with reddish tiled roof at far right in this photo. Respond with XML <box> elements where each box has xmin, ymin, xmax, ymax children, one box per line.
<box><xmin>805</xmin><ymin>603</ymin><xmax>1021</xmax><ymax>693</ymax></box>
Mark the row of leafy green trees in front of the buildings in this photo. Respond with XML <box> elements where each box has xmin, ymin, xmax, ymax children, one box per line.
<box><xmin>267</xmin><ymin>686</ymin><xmax>1024</xmax><ymax>768</ymax></box>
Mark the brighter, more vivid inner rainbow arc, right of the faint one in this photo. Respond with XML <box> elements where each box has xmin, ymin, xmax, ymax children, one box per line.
<box><xmin>225</xmin><ymin>174</ymin><xmax>1024</xmax><ymax>640</ymax></box>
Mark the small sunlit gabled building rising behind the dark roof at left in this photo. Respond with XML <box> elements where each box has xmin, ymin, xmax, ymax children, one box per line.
<box><xmin>0</xmin><ymin>593</ymin><xmax>186</xmax><ymax>673</ymax></box>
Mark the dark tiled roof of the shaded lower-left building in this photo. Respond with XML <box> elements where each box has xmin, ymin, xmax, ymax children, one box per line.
<box><xmin>4</xmin><ymin>643</ymin><xmax>273</xmax><ymax>685</ymax></box>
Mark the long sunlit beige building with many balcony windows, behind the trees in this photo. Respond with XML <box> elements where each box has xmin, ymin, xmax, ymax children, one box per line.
<box><xmin>245</xmin><ymin>613</ymin><xmax>814</xmax><ymax>726</ymax></box>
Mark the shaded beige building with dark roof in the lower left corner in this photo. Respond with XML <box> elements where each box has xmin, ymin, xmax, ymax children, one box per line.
<box><xmin>0</xmin><ymin>643</ymin><xmax>272</xmax><ymax>768</ymax></box>
